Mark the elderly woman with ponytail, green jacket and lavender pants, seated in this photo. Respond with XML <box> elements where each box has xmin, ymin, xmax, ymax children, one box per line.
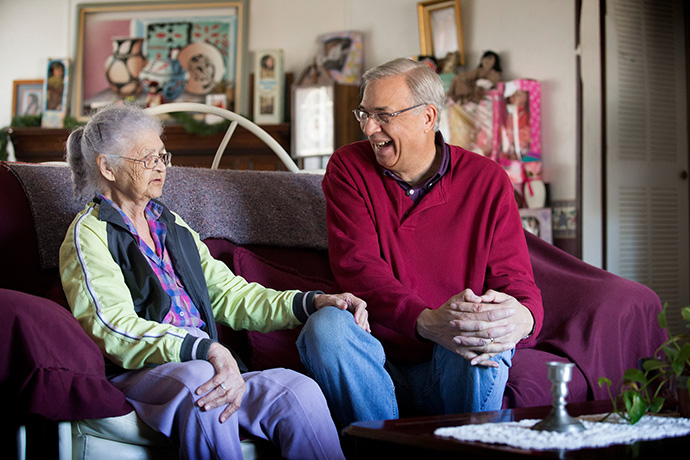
<box><xmin>60</xmin><ymin>105</ymin><xmax>369</xmax><ymax>459</ymax></box>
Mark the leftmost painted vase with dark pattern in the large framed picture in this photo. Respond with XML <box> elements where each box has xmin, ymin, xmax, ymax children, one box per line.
<box><xmin>105</xmin><ymin>37</ymin><xmax>146</xmax><ymax>97</ymax></box>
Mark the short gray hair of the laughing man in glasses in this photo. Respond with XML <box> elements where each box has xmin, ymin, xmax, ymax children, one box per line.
<box><xmin>360</xmin><ymin>58</ymin><xmax>446</xmax><ymax>131</ymax></box>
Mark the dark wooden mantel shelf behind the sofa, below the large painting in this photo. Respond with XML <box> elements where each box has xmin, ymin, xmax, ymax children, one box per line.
<box><xmin>10</xmin><ymin>123</ymin><xmax>290</xmax><ymax>171</ymax></box>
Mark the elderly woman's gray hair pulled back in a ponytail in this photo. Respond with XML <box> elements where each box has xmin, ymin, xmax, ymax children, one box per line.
<box><xmin>67</xmin><ymin>104</ymin><xmax>163</xmax><ymax>200</ymax></box>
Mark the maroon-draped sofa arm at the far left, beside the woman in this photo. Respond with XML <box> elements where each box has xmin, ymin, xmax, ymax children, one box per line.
<box><xmin>0</xmin><ymin>289</ymin><xmax>132</xmax><ymax>420</ymax></box>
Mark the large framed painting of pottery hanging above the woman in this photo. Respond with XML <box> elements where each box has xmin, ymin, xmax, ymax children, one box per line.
<box><xmin>72</xmin><ymin>0</ymin><xmax>248</xmax><ymax>120</ymax></box>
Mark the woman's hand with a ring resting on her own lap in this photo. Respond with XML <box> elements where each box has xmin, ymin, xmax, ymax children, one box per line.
<box><xmin>196</xmin><ymin>342</ymin><xmax>246</xmax><ymax>423</ymax></box>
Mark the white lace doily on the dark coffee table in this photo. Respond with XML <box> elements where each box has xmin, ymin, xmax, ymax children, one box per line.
<box><xmin>434</xmin><ymin>414</ymin><xmax>690</xmax><ymax>450</ymax></box>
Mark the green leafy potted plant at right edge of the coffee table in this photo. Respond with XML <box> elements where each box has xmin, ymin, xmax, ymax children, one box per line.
<box><xmin>599</xmin><ymin>305</ymin><xmax>690</xmax><ymax>424</ymax></box>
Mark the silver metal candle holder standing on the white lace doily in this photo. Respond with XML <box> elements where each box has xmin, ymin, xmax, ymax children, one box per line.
<box><xmin>532</xmin><ymin>361</ymin><xmax>585</xmax><ymax>433</ymax></box>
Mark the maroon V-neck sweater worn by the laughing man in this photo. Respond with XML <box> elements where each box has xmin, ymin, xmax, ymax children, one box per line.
<box><xmin>323</xmin><ymin>141</ymin><xmax>544</xmax><ymax>363</ymax></box>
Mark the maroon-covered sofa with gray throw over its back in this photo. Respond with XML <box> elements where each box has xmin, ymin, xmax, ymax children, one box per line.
<box><xmin>0</xmin><ymin>163</ymin><xmax>664</xmax><ymax>434</ymax></box>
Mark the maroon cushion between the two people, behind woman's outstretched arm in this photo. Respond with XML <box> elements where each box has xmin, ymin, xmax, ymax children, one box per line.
<box><xmin>233</xmin><ymin>247</ymin><xmax>334</xmax><ymax>373</ymax></box>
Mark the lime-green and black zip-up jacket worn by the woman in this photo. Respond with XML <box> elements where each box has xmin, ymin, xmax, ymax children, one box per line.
<box><xmin>60</xmin><ymin>198</ymin><xmax>314</xmax><ymax>369</ymax></box>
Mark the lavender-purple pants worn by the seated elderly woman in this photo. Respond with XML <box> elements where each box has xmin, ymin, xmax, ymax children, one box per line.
<box><xmin>111</xmin><ymin>361</ymin><xmax>344</xmax><ymax>459</ymax></box>
